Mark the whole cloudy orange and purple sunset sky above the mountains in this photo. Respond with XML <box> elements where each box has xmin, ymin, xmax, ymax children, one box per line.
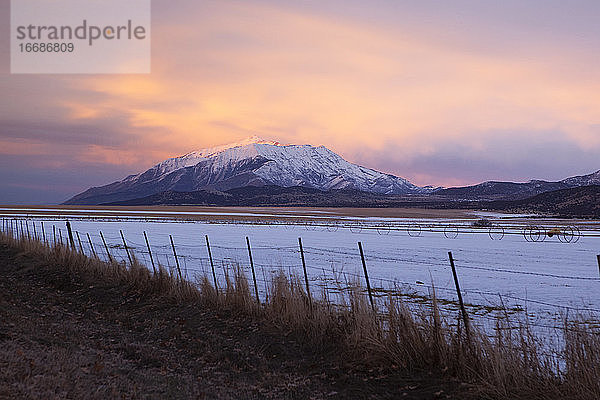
<box><xmin>0</xmin><ymin>0</ymin><xmax>600</xmax><ymax>204</ymax></box>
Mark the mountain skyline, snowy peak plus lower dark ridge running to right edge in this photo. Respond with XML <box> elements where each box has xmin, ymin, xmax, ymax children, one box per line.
<box><xmin>63</xmin><ymin>136</ymin><xmax>600</xmax><ymax>205</ymax></box>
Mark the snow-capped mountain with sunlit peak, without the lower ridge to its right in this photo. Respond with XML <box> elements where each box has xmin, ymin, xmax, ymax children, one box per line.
<box><xmin>65</xmin><ymin>136</ymin><xmax>422</xmax><ymax>204</ymax></box>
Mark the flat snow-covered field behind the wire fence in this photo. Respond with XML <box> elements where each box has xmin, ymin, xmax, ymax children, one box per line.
<box><xmin>0</xmin><ymin>209</ymin><xmax>600</xmax><ymax>336</ymax></box>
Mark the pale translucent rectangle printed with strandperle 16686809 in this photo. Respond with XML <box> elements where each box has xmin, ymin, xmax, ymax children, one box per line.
<box><xmin>10</xmin><ymin>0</ymin><xmax>151</xmax><ymax>74</ymax></box>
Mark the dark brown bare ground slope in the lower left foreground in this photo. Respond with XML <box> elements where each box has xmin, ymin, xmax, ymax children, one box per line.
<box><xmin>0</xmin><ymin>244</ymin><xmax>471</xmax><ymax>399</ymax></box>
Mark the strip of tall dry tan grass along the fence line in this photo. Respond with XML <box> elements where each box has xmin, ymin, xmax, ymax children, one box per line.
<box><xmin>1</xmin><ymin>230</ymin><xmax>600</xmax><ymax>399</ymax></box>
